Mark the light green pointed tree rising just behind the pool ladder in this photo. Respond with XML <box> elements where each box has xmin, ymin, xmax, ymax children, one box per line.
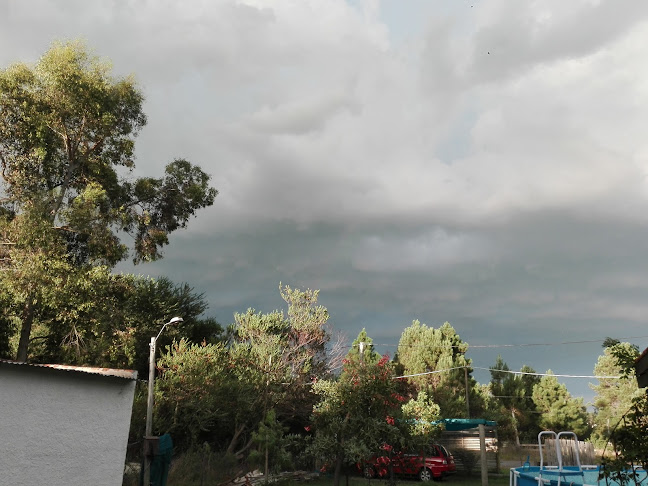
<box><xmin>533</xmin><ymin>370</ymin><xmax>590</xmax><ymax>439</ymax></box>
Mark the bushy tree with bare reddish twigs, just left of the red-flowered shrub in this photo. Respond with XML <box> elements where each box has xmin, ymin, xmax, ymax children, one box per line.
<box><xmin>230</xmin><ymin>284</ymin><xmax>331</xmax><ymax>444</ymax></box>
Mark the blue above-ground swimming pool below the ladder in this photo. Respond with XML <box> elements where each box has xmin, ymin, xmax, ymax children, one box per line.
<box><xmin>510</xmin><ymin>466</ymin><xmax>648</xmax><ymax>486</ymax></box>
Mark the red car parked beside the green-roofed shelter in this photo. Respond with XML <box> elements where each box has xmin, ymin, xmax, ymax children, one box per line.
<box><xmin>362</xmin><ymin>444</ymin><xmax>457</xmax><ymax>481</ymax></box>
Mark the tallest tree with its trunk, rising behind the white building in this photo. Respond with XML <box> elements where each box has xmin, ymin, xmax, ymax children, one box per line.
<box><xmin>0</xmin><ymin>42</ymin><xmax>217</xmax><ymax>361</ymax></box>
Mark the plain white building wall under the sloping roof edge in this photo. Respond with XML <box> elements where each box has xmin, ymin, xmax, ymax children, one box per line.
<box><xmin>0</xmin><ymin>363</ymin><xmax>135</xmax><ymax>486</ymax></box>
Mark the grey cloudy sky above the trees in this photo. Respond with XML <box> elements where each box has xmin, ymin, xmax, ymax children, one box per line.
<box><xmin>0</xmin><ymin>0</ymin><xmax>648</xmax><ymax>402</ymax></box>
